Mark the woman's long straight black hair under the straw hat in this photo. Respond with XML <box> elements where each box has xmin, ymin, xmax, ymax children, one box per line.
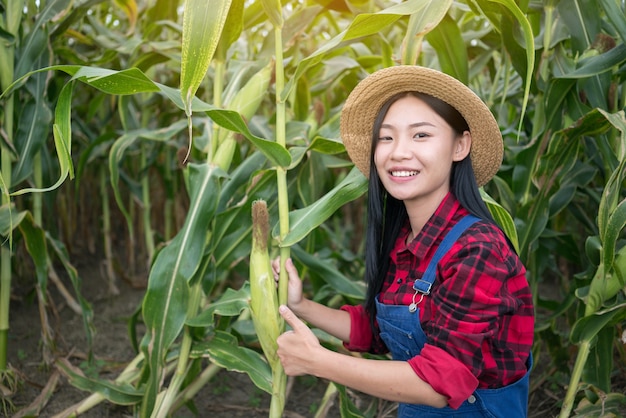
<box><xmin>365</xmin><ymin>92</ymin><xmax>495</xmax><ymax>327</ymax></box>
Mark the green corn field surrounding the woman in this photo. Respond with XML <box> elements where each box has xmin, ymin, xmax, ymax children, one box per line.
<box><xmin>0</xmin><ymin>0</ymin><xmax>626</xmax><ymax>418</ymax></box>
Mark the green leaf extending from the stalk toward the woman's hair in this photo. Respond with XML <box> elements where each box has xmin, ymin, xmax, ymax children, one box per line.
<box><xmin>272</xmin><ymin>168</ymin><xmax>367</xmax><ymax>247</ymax></box>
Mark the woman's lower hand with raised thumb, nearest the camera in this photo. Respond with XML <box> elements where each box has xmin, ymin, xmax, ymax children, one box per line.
<box><xmin>276</xmin><ymin>305</ymin><xmax>324</xmax><ymax>376</ymax></box>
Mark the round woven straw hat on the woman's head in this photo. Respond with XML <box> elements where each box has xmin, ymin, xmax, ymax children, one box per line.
<box><xmin>340</xmin><ymin>65</ymin><xmax>504</xmax><ymax>187</ymax></box>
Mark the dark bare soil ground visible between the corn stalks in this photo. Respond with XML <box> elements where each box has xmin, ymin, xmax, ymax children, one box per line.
<box><xmin>1</xmin><ymin>250</ymin><xmax>588</xmax><ymax>418</ymax></box>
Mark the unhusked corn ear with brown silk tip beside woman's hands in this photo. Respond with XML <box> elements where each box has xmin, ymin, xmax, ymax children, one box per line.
<box><xmin>250</xmin><ymin>200</ymin><xmax>281</xmax><ymax>369</ymax></box>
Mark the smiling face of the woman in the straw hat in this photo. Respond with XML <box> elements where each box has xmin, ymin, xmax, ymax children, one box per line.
<box><xmin>374</xmin><ymin>96</ymin><xmax>471</xmax><ymax>210</ymax></box>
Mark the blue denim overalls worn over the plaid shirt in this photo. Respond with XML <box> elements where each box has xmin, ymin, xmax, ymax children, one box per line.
<box><xmin>376</xmin><ymin>215</ymin><xmax>532</xmax><ymax>418</ymax></box>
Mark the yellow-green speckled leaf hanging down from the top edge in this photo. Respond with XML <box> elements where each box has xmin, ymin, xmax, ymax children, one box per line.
<box><xmin>180</xmin><ymin>0</ymin><xmax>231</xmax><ymax>116</ymax></box>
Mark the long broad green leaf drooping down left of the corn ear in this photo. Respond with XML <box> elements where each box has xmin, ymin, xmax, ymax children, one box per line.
<box><xmin>142</xmin><ymin>164</ymin><xmax>220</xmax><ymax>416</ymax></box>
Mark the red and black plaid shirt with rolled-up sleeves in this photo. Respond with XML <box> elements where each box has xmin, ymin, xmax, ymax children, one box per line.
<box><xmin>342</xmin><ymin>193</ymin><xmax>534</xmax><ymax>407</ymax></box>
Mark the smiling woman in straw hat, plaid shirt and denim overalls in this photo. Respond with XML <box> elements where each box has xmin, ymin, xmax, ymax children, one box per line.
<box><xmin>273</xmin><ymin>66</ymin><xmax>534</xmax><ymax>417</ymax></box>
